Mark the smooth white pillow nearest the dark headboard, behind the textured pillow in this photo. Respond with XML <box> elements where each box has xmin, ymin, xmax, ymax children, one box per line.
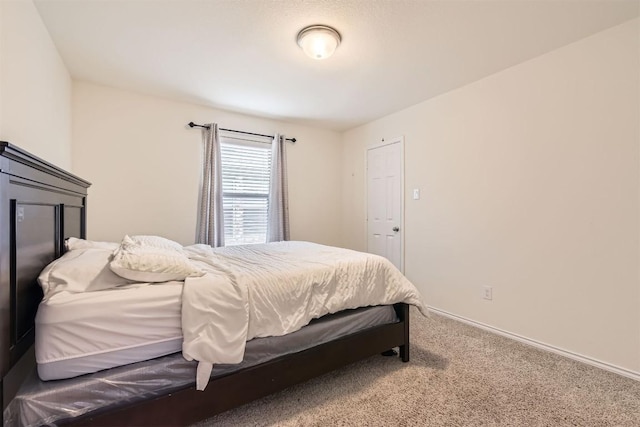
<box><xmin>38</xmin><ymin>248</ymin><xmax>132</xmax><ymax>299</ymax></box>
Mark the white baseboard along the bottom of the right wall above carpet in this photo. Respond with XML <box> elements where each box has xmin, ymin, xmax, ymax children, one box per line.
<box><xmin>429</xmin><ymin>306</ymin><xmax>640</xmax><ymax>381</ymax></box>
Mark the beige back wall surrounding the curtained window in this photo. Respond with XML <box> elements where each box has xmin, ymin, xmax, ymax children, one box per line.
<box><xmin>73</xmin><ymin>82</ymin><xmax>342</xmax><ymax>245</ymax></box>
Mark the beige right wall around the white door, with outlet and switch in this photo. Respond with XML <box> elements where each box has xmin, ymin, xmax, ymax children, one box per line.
<box><xmin>342</xmin><ymin>20</ymin><xmax>640</xmax><ymax>373</ymax></box>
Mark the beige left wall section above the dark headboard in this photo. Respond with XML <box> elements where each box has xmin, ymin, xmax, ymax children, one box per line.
<box><xmin>0</xmin><ymin>0</ymin><xmax>71</xmax><ymax>170</ymax></box>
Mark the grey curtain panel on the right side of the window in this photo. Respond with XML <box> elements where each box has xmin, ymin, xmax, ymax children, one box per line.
<box><xmin>267</xmin><ymin>134</ymin><xmax>289</xmax><ymax>242</ymax></box>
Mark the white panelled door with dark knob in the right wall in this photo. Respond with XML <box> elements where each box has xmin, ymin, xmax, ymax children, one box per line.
<box><xmin>367</xmin><ymin>138</ymin><xmax>404</xmax><ymax>271</ymax></box>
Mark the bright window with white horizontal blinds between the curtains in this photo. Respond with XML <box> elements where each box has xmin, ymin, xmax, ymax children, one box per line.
<box><xmin>220</xmin><ymin>138</ymin><xmax>271</xmax><ymax>246</ymax></box>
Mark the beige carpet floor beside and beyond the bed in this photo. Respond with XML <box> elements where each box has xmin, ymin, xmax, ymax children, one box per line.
<box><xmin>197</xmin><ymin>310</ymin><xmax>640</xmax><ymax>427</ymax></box>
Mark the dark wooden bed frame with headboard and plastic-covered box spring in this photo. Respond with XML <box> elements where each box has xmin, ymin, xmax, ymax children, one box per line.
<box><xmin>0</xmin><ymin>142</ymin><xmax>422</xmax><ymax>425</ymax></box>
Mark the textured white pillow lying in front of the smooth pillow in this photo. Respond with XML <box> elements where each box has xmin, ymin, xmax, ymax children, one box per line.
<box><xmin>110</xmin><ymin>242</ymin><xmax>204</xmax><ymax>282</ymax></box>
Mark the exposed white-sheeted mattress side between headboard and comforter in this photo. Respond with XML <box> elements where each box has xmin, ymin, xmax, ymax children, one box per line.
<box><xmin>35</xmin><ymin>282</ymin><xmax>183</xmax><ymax>380</ymax></box>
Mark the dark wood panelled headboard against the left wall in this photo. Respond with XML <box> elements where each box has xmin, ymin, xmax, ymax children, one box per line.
<box><xmin>0</xmin><ymin>141</ymin><xmax>91</xmax><ymax>409</ymax></box>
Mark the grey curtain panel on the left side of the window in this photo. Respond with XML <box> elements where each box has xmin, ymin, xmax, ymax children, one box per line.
<box><xmin>196</xmin><ymin>123</ymin><xmax>224</xmax><ymax>247</ymax></box>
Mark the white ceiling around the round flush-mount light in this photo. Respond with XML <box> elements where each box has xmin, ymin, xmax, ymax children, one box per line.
<box><xmin>35</xmin><ymin>0</ymin><xmax>639</xmax><ymax>130</ymax></box>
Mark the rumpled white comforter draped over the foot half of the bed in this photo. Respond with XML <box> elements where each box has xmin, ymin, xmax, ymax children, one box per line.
<box><xmin>182</xmin><ymin>242</ymin><xmax>427</xmax><ymax>390</ymax></box>
